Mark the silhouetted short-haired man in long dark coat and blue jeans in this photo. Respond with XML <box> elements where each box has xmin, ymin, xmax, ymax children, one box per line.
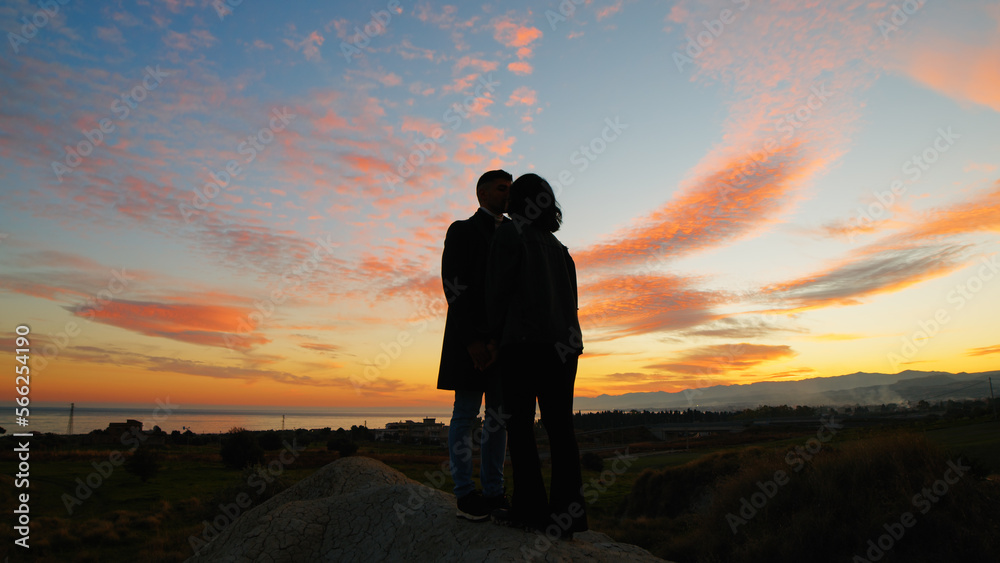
<box><xmin>437</xmin><ymin>170</ymin><xmax>513</xmax><ymax>521</ymax></box>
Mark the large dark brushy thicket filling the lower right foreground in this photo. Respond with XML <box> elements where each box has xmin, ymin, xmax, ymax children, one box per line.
<box><xmin>615</xmin><ymin>433</ymin><xmax>1000</xmax><ymax>563</ymax></box>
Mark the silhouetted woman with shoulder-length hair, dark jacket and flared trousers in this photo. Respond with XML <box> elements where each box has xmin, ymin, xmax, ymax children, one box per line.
<box><xmin>486</xmin><ymin>174</ymin><xmax>587</xmax><ymax>538</ymax></box>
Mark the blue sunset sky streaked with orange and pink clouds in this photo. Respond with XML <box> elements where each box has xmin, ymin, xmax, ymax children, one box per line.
<box><xmin>0</xmin><ymin>0</ymin><xmax>1000</xmax><ymax>407</ymax></box>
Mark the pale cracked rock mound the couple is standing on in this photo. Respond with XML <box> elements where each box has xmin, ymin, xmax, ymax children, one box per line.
<box><xmin>187</xmin><ymin>457</ymin><xmax>663</xmax><ymax>563</ymax></box>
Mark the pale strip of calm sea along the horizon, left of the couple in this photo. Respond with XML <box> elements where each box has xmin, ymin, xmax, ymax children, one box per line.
<box><xmin>6</xmin><ymin>402</ymin><xmax>451</xmax><ymax>434</ymax></box>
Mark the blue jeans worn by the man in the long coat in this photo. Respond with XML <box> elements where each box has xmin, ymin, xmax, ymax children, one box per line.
<box><xmin>448</xmin><ymin>374</ymin><xmax>507</xmax><ymax>498</ymax></box>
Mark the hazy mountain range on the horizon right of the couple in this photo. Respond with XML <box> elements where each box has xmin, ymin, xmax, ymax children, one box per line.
<box><xmin>573</xmin><ymin>370</ymin><xmax>1000</xmax><ymax>411</ymax></box>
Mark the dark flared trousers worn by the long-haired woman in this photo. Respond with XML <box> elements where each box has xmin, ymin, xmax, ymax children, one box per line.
<box><xmin>500</xmin><ymin>344</ymin><xmax>587</xmax><ymax>532</ymax></box>
